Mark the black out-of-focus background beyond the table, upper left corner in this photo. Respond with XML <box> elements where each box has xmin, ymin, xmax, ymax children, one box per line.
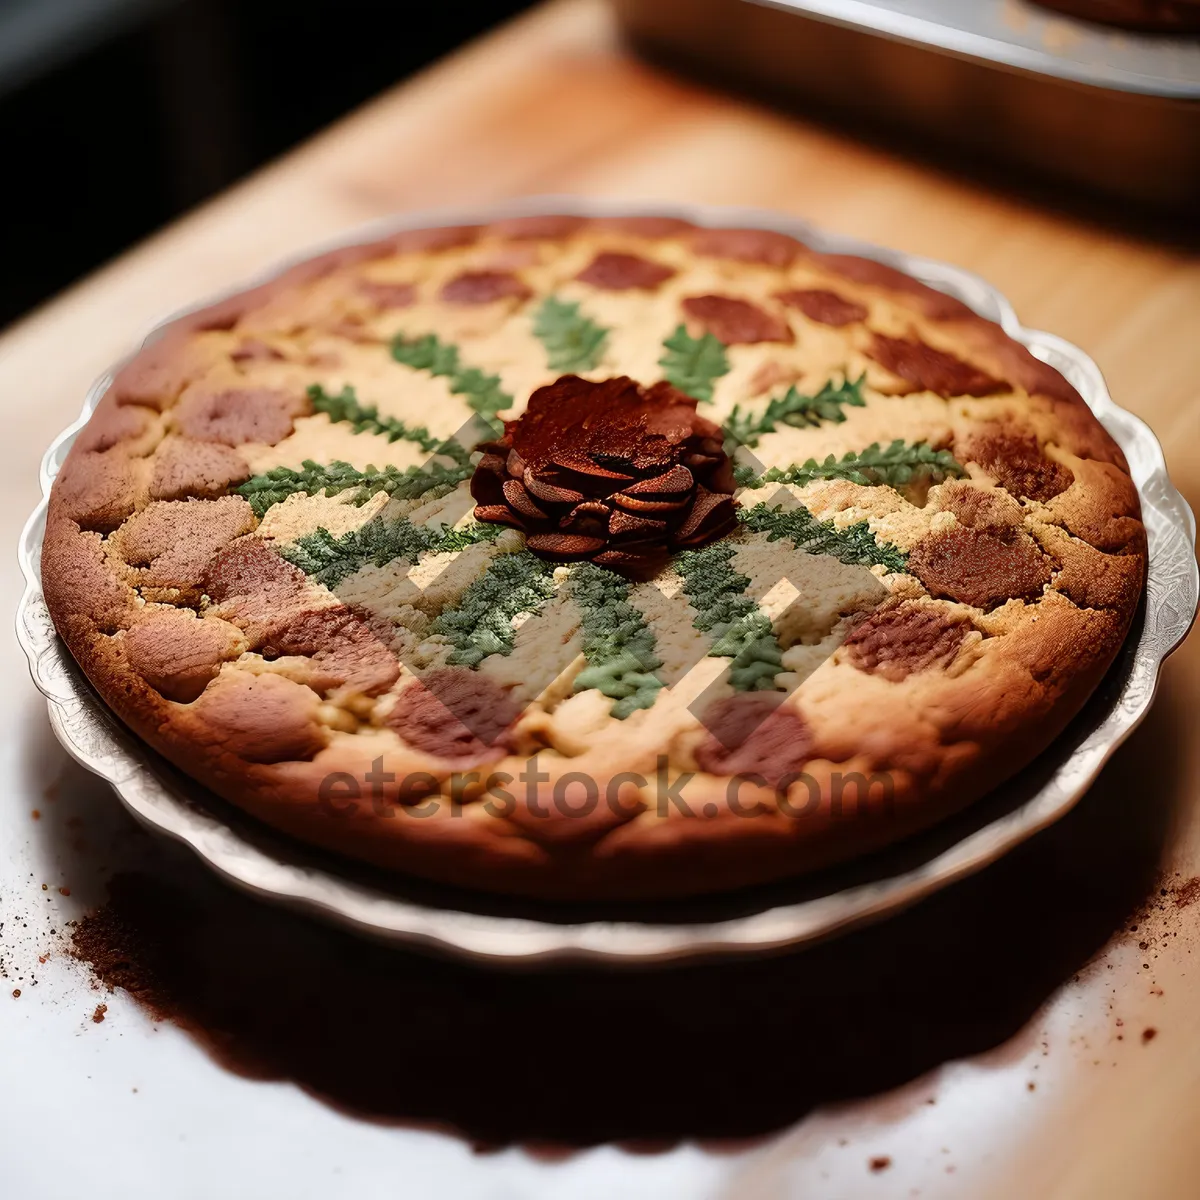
<box><xmin>0</xmin><ymin>0</ymin><xmax>532</xmax><ymax>326</ymax></box>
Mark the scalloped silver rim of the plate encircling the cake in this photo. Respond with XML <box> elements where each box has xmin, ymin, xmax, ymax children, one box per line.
<box><xmin>17</xmin><ymin>196</ymin><xmax>1200</xmax><ymax>965</ymax></box>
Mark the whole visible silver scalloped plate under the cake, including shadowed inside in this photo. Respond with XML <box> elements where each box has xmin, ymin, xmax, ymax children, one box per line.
<box><xmin>17</xmin><ymin>197</ymin><xmax>1200</xmax><ymax>964</ymax></box>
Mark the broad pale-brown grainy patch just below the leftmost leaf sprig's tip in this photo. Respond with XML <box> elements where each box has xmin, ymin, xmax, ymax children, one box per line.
<box><xmin>110</xmin><ymin>496</ymin><xmax>256</xmax><ymax>594</ymax></box>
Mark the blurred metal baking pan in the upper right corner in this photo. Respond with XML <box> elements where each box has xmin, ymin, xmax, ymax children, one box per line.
<box><xmin>612</xmin><ymin>0</ymin><xmax>1200</xmax><ymax>212</ymax></box>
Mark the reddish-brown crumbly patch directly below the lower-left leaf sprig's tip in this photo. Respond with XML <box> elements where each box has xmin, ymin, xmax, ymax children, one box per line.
<box><xmin>262</xmin><ymin>608</ymin><xmax>400</xmax><ymax>696</ymax></box>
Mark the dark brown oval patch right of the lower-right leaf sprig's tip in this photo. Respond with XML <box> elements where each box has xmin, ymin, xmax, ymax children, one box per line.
<box><xmin>908</xmin><ymin>528</ymin><xmax>1051</xmax><ymax>610</ymax></box>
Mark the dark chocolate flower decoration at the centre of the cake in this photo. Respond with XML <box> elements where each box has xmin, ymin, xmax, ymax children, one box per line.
<box><xmin>470</xmin><ymin>376</ymin><xmax>737</xmax><ymax>580</ymax></box>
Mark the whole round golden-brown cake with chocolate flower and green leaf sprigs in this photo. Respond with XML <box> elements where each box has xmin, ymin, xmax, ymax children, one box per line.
<box><xmin>42</xmin><ymin>216</ymin><xmax>1146</xmax><ymax>899</ymax></box>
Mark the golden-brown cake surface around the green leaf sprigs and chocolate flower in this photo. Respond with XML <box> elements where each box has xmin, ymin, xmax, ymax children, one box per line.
<box><xmin>42</xmin><ymin>216</ymin><xmax>1146</xmax><ymax>898</ymax></box>
